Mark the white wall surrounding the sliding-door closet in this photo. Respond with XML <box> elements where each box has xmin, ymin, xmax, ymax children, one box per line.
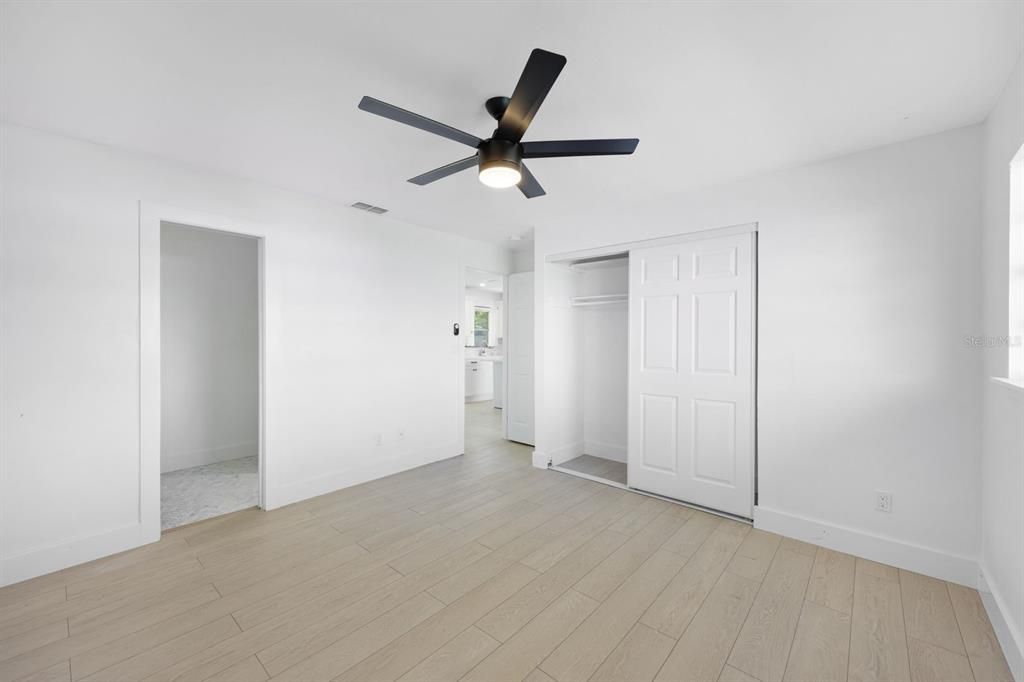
<box><xmin>536</xmin><ymin>126</ymin><xmax>982</xmax><ymax>584</ymax></box>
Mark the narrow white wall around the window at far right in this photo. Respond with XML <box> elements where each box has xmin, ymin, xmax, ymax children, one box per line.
<box><xmin>975</xmin><ymin>54</ymin><xmax>1024</xmax><ymax>680</ymax></box>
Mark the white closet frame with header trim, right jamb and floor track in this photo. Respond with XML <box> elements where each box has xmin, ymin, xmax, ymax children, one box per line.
<box><xmin>535</xmin><ymin>222</ymin><xmax>759</xmax><ymax>520</ymax></box>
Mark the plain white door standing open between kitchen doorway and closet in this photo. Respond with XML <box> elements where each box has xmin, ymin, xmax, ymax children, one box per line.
<box><xmin>505</xmin><ymin>272</ymin><xmax>534</xmax><ymax>445</ymax></box>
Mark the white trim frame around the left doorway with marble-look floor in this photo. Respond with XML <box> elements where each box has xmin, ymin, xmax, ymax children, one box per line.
<box><xmin>138</xmin><ymin>201</ymin><xmax>272</xmax><ymax>542</ymax></box>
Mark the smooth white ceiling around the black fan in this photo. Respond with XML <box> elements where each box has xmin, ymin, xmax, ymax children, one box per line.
<box><xmin>0</xmin><ymin>0</ymin><xmax>1024</xmax><ymax>246</ymax></box>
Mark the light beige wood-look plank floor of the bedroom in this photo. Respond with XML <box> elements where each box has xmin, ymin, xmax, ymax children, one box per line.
<box><xmin>0</xmin><ymin>406</ymin><xmax>1010</xmax><ymax>682</ymax></box>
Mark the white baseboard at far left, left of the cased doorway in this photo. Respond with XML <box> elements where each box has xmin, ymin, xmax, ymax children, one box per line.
<box><xmin>0</xmin><ymin>523</ymin><xmax>153</xmax><ymax>587</ymax></box>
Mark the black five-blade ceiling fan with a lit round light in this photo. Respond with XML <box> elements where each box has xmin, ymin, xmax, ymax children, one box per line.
<box><xmin>359</xmin><ymin>49</ymin><xmax>640</xmax><ymax>199</ymax></box>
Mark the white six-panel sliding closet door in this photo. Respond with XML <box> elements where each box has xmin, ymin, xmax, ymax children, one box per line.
<box><xmin>628</xmin><ymin>233</ymin><xmax>755</xmax><ymax>518</ymax></box>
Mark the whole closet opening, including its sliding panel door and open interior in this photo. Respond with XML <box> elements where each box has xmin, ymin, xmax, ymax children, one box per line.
<box><xmin>535</xmin><ymin>223</ymin><xmax>757</xmax><ymax>519</ymax></box>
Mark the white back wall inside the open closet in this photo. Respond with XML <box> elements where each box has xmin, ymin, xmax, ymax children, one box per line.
<box><xmin>575</xmin><ymin>260</ymin><xmax>629</xmax><ymax>462</ymax></box>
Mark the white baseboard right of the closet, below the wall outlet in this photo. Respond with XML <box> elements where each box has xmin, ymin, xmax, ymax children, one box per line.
<box><xmin>754</xmin><ymin>507</ymin><xmax>978</xmax><ymax>587</ymax></box>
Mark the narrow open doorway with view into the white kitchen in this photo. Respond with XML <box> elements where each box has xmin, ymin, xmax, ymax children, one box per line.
<box><xmin>462</xmin><ymin>267</ymin><xmax>506</xmax><ymax>453</ymax></box>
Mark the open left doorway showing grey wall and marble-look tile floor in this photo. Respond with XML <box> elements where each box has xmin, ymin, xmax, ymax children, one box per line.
<box><xmin>160</xmin><ymin>221</ymin><xmax>260</xmax><ymax>530</ymax></box>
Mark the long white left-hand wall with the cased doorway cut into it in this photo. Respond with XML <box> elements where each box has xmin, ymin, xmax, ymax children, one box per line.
<box><xmin>0</xmin><ymin>125</ymin><xmax>508</xmax><ymax>584</ymax></box>
